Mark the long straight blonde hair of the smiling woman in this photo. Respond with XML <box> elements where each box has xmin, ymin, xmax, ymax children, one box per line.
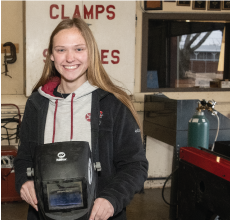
<box><xmin>33</xmin><ymin>18</ymin><xmax>141</xmax><ymax>131</ymax></box>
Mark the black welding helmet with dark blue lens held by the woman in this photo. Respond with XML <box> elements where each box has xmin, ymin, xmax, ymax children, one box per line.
<box><xmin>31</xmin><ymin>141</ymin><xmax>97</xmax><ymax>220</ymax></box>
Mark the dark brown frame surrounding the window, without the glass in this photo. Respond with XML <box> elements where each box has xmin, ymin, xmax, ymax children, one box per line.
<box><xmin>141</xmin><ymin>13</ymin><xmax>230</xmax><ymax>92</ymax></box>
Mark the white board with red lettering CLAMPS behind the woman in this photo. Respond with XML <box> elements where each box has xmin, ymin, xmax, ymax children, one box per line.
<box><xmin>26</xmin><ymin>0</ymin><xmax>136</xmax><ymax>96</ymax></box>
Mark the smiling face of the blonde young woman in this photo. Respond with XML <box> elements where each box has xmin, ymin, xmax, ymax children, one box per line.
<box><xmin>50</xmin><ymin>27</ymin><xmax>89</xmax><ymax>84</ymax></box>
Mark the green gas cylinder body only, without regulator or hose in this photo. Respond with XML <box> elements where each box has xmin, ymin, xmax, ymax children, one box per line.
<box><xmin>188</xmin><ymin>111</ymin><xmax>209</xmax><ymax>149</ymax></box>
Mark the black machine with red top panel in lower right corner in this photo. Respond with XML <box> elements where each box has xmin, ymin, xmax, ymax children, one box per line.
<box><xmin>178</xmin><ymin>147</ymin><xmax>230</xmax><ymax>220</ymax></box>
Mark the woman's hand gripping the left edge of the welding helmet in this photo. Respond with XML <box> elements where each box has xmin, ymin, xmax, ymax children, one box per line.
<box><xmin>20</xmin><ymin>181</ymin><xmax>38</xmax><ymax>211</ymax></box>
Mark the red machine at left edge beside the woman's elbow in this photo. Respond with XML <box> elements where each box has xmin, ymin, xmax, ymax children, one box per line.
<box><xmin>1</xmin><ymin>146</ymin><xmax>22</xmax><ymax>202</ymax></box>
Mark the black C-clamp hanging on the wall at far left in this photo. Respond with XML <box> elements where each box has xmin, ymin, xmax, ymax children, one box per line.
<box><xmin>2</xmin><ymin>42</ymin><xmax>17</xmax><ymax>78</ymax></box>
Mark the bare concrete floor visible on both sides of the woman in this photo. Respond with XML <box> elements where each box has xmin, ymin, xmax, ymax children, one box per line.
<box><xmin>1</xmin><ymin>188</ymin><xmax>170</xmax><ymax>220</ymax></box>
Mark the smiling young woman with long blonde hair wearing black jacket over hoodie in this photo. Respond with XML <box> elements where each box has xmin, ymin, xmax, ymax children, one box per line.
<box><xmin>15</xmin><ymin>18</ymin><xmax>148</xmax><ymax>220</ymax></box>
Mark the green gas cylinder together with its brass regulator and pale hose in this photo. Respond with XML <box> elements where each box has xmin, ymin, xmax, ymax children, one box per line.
<box><xmin>188</xmin><ymin>99</ymin><xmax>219</xmax><ymax>151</ymax></box>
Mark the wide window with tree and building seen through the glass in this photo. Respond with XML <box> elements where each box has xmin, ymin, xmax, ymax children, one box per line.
<box><xmin>142</xmin><ymin>14</ymin><xmax>230</xmax><ymax>92</ymax></box>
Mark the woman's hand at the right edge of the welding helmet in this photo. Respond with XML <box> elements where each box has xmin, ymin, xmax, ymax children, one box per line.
<box><xmin>89</xmin><ymin>198</ymin><xmax>114</xmax><ymax>220</ymax></box>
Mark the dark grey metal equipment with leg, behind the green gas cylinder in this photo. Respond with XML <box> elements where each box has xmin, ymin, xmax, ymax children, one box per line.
<box><xmin>143</xmin><ymin>93</ymin><xmax>230</xmax><ymax>220</ymax></box>
